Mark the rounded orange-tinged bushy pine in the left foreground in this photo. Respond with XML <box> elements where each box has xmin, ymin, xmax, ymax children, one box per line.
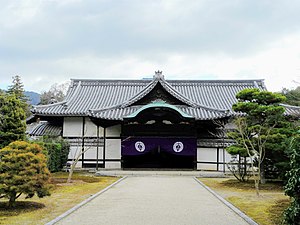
<box><xmin>0</xmin><ymin>141</ymin><xmax>50</xmax><ymax>207</ymax></box>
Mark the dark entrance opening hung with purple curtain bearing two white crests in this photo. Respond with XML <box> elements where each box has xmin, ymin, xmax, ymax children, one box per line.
<box><xmin>122</xmin><ymin>137</ymin><xmax>196</xmax><ymax>169</ymax></box>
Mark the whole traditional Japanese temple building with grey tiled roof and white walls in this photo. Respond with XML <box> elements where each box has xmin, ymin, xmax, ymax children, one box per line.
<box><xmin>30</xmin><ymin>71</ymin><xmax>299</xmax><ymax>171</ymax></box>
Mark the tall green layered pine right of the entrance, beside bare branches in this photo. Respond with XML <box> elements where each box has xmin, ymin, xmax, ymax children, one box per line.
<box><xmin>228</xmin><ymin>88</ymin><xmax>289</xmax><ymax>195</ymax></box>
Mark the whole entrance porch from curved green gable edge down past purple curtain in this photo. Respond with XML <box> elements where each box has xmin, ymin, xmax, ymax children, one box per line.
<box><xmin>121</xmin><ymin>101</ymin><xmax>197</xmax><ymax>169</ymax></box>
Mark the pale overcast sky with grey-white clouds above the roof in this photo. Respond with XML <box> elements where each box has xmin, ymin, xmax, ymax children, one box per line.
<box><xmin>0</xmin><ymin>0</ymin><xmax>300</xmax><ymax>92</ymax></box>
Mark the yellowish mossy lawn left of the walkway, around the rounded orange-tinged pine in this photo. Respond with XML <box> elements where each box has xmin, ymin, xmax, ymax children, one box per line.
<box><xmin>0</xmin><ymin>172</ymin><xmax>119</xmax><ymax>225</ymax></box>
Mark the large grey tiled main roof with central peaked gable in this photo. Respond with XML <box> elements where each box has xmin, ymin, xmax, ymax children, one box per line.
<box><xmin>33</xmin><ymin>76</ymin><xmax>265</xmax><ymax>120</ymax></box>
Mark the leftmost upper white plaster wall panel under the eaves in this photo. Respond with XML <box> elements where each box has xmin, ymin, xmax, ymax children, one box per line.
<box><xmin>63</xmin><ymin>117</ymin><xmax>83</xmax><ymax>137</ymax></box>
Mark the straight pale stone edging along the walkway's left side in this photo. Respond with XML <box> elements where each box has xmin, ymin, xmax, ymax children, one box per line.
<box><xmin>45</xmin><ymin>176</ymin><xmax>127</xmax><ymax>225</ymax></box>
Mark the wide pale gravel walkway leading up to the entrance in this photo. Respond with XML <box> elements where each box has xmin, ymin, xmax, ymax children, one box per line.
<box><xmin>58</xmin><ymin>176</ymin><xmax>248</xmax><ymax>225</ymax></box>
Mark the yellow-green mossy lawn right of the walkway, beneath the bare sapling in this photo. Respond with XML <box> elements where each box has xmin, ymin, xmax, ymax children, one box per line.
<box><xmin>199</xmin><ymin>178</ymin><xmax>289</xmax><ymax>225</ymax></box>
